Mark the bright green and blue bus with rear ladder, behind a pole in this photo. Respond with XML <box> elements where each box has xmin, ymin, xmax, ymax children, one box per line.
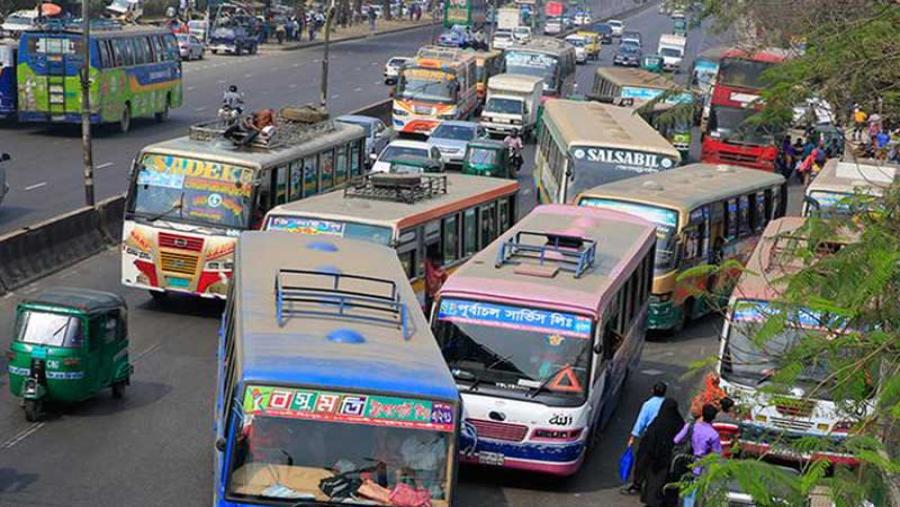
<box><xmin>16</xmin><ymin>29</ymin><xmax>182</xmax><ymax>132</ymax></box>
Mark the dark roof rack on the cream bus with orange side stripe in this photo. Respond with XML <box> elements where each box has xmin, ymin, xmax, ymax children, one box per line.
<box><xmin>344</xmin><ymin>173</ymin><xmax>447</xmax><ymax>204</ymax></box>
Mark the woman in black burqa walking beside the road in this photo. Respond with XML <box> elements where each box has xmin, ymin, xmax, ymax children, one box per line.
<box><xmin>635</xmin><ymin>398</ymin><xmax>684</xmax><ymax>507</ymax></box>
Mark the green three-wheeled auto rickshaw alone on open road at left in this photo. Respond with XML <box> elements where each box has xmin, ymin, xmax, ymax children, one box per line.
<box><xmin>7</xmin><ymin>288</ymin><xmax>134</xmax><ymax>421</ymax></box>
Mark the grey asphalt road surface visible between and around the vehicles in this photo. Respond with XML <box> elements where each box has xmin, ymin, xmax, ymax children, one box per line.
<box><xmin>0</xmin><ymin>3</ymin><xmax>760</xmax><ymax>507</ymax></box>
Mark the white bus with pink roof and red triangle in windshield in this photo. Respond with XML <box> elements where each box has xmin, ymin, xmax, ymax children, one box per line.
<box><xmin>431</xmin><ymin>205</ymin><xmax>656</xmax><ymax>475</ymax></box>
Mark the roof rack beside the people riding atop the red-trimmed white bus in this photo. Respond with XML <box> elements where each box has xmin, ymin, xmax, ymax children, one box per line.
<box><xmin>190</xmin><ymin>108</ymin><xmax>336</xmax><ymax>150</ymax></box>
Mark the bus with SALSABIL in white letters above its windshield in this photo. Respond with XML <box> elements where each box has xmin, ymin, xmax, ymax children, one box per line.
<box><xmin>534</xmin><ymin>99</ymin><xmax>681</xmax><ymax>204</ymax></box>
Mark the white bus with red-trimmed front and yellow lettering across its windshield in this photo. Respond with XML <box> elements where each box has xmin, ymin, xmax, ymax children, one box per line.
<box><xmin>122</xmin><ymin>121</ymin><xmax>366</xmax><ymax>298</ymax></box>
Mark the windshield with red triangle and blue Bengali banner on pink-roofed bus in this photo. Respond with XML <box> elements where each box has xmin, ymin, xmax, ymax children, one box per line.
<box><xmin>434</xmin><ymin>299</ymin><xmax>593</xmax><ymax>406</ymax></box>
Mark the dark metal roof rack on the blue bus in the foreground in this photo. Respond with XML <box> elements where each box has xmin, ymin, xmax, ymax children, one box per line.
<box><xmin>275</xmin><ymin>268</ymin><xmax>409</xmax><ymax>339</ymax></box>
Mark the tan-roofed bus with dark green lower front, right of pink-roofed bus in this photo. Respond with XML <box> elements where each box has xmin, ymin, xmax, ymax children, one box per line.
<box><xmin>576</xmin><ymin>164</ymin><xmax>787</xmax><ymax>331</ymax></box>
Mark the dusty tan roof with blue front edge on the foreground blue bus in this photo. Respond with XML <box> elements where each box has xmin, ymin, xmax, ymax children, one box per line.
<box><xmin>234</xmin><ymin>231</ymin><xmax>459</xmax><ymax>401</ymax></box>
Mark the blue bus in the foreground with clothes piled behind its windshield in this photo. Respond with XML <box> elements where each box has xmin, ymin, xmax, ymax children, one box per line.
<box><xmin>214</xmin><ymin>231</ymin><xmax>460</xmax><ymax>507</ymax></box>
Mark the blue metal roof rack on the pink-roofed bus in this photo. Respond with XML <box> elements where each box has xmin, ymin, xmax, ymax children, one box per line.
<box><xmin>495</xmin><ymin>231</ymin><xmax>597</xmax><ymax>278</ymax></box>
